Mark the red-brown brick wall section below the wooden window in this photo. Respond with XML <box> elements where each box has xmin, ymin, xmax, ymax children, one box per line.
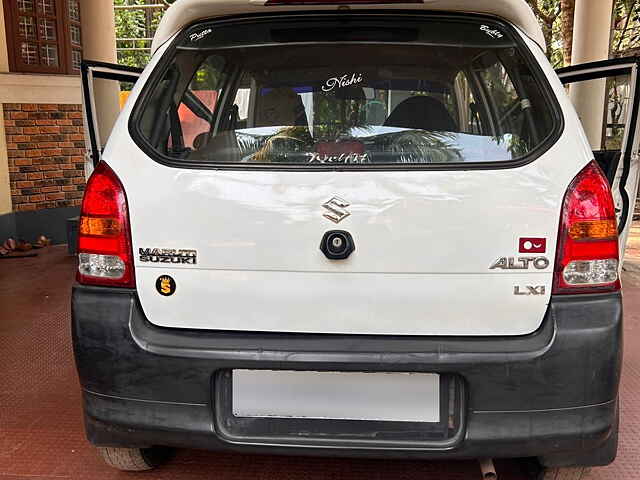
<box><xmin>3</xmin><ymin>103</ymin><xmax>85</xmax><ymax>211</ymax></box>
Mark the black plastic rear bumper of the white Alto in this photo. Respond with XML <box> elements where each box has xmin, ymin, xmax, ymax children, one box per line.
<box><xmin>72</xmin><ymin>287</ymin><xmax>622</xmax><ymax>464</ymax></box>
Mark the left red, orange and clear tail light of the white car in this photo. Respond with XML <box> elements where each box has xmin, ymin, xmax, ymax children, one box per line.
<box><xmin>77</xmin><ymin>162</ymin><xmax>135</xmax><ymax>287</ymax></box>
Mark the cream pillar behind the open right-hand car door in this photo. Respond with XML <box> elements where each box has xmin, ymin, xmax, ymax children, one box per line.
<box><xmin>570</xmin><ymin>0</ymin><xmax>613</xmax><ymax>150</ymax></box>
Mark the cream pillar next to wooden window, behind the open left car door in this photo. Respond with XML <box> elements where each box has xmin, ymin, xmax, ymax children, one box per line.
<box><xmin>80</xmin><ymin>0</ymin><xmax>120</xmax><ymax>146</ymax></box>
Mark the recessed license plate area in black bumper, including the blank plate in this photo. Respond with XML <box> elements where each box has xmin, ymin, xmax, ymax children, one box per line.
<box><xmin>213</xmin><ymin>369</ymin><xmax>464</xmax><ymax>450</ymax></box>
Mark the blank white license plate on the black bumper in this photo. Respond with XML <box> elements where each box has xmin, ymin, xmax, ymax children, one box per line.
<box><xmin>232</xmin><ymin>370</ymin><xmax>440</xmax><ymax>423</ymax></box>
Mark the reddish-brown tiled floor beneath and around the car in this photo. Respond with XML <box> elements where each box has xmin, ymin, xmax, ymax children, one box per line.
<box><xmin>0</xmin><ymin>247</ymin><xmax>640</xmax><ymax>480</ymax></box>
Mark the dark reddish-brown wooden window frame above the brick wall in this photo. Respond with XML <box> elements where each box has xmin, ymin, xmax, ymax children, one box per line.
<box><xmin>2</xmin><ymin>0</ymin><xmax>82</xmax><ymax>75</ymax></box>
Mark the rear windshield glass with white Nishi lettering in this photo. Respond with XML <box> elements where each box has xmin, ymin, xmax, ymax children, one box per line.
<box><xmin>134</xmin><ymin>16</ymin><xmax>555</xmax><ymax>166</ymax></box>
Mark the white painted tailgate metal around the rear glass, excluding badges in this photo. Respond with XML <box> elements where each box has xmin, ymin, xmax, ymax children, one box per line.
<box><xmin>103</xmin><ymin>31</ymin><xmax>593</xmax><ymax>336</ymax></box>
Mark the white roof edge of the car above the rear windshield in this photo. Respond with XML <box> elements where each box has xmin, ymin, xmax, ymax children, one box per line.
<box><xmin>151</xmin><ymin>0</ymin><xmax>546</xmax><ymax>54</ymax></box>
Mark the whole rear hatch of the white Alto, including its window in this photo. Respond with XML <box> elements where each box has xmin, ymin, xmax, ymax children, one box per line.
<box><xmin>110</xmin><ymin>14</ymin><xmax>568</xmax><ymax>336</ymax></box>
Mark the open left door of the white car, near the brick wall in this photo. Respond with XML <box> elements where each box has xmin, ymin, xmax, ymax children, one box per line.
<box><xmin>81</xmin><ymin>60</ymin><xmax>142</xmax><ymax>178</ymax></box>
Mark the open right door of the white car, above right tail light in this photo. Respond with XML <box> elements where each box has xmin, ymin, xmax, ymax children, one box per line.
<box><xmin>558</xmin><ymin>57</ymin><xmax>640</xmax><ymax>256</ymax></box>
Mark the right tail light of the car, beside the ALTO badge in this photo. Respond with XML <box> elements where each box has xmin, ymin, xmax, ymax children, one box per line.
<box><xmin>553</xmin><ymin>162</ymin><xmax>620</xmax><ymax>294</ymax></box>
